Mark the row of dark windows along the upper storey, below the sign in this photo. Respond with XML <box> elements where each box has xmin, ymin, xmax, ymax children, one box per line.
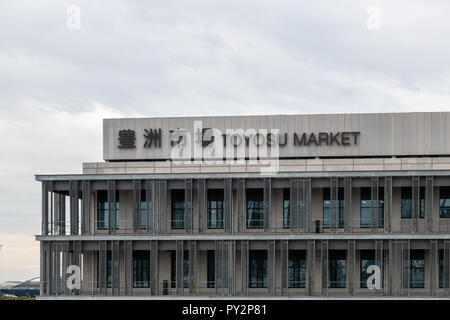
<box><xmin>97</xmin><ymin>187</ymin><xmax>450</xmax><ymax>229</ymax></box>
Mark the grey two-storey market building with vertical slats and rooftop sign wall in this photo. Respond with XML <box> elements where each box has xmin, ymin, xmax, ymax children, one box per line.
<box><xmin>36</xmin><ymin>112</ymin><xmax>450</xmax><ymax>298</ymax></box>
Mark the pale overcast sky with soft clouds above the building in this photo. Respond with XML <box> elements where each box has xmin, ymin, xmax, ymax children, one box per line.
<box><xmin>0</xmin><ymin>0</ymin><xmax>450</xmax><ymax>282</ymax></box>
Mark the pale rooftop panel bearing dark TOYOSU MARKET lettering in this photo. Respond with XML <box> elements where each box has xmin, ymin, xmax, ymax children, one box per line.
<box><xmin>103</xmin><ymin>112</ymin><xmax>450</xmax><ymax>161</ymax></box>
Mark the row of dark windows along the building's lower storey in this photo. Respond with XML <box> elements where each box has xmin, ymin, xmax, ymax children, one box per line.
<box><xmin>97</xmin><ymin>250</ymin><xmax>444</xmax><ymax>288</ymax></box>
